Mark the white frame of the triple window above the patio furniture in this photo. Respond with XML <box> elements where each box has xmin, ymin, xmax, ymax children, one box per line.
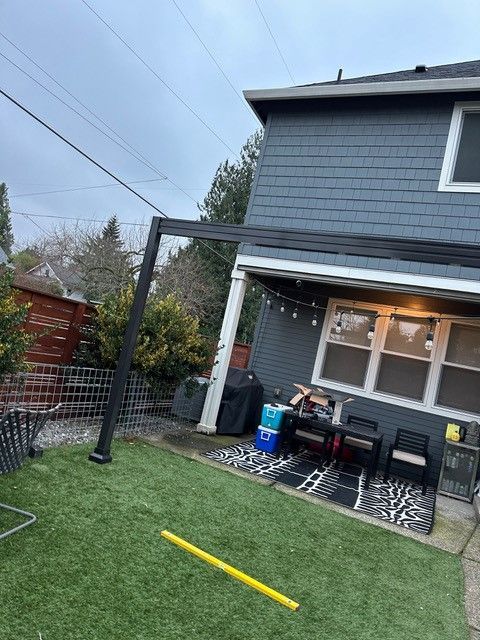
<box><xmin>311</xmin><ymin>298</ymin><xmax>480</xmax><ymax>422</ymax></box>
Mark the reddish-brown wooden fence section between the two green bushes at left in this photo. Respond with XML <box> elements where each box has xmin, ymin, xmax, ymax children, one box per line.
<box><xmin>15</xmin><ymin>285</ymin><xmax>95</xmax><ymax>365</ymax></box>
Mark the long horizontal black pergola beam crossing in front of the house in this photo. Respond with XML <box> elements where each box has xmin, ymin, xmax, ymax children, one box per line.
<box><xmin>160</xmin><ymin>218</ymin><xmax>480</xmax><ymax>268</ymax></box>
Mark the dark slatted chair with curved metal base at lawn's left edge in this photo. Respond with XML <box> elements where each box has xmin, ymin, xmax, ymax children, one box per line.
<box><xmin>0</xmin><ymin>405</ymin><xmax>60</xmax><ymax>540</ymax></box>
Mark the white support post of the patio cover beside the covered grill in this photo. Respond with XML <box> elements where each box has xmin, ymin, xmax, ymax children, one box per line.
<box><xmin>197</xmin><ymin>269</ymin><xmax>248</xmax><ymax>435</ymax></box>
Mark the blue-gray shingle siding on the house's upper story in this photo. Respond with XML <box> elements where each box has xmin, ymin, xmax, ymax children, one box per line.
<box><xmin>241</xmin><ymin>95</ymin><xmax>480</xmax><ymax>279</ymax></box>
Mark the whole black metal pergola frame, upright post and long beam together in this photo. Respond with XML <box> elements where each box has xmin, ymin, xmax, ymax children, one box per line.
<box><xmin>89</xmin><ymin>216</ymin><xmax>480</xmax><ymax>464</ymax></box>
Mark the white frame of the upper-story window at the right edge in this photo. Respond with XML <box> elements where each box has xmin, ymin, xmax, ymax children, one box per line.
<box><xmin>438</xmin><ymin>101</ymin><xmax>480</xmax><ymax>193</ymax></box>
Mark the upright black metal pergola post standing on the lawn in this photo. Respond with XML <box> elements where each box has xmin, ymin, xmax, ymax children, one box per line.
<box><xmin>88</xmin><ymin>216</ymin><xmax>162</xmax><ymax>464</ymax></box>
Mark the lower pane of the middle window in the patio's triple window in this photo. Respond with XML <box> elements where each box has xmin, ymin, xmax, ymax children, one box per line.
<box><xmin>376</xmin><ymin>353</ymin><xmax>430</xmax><ymax>400</ymax></box>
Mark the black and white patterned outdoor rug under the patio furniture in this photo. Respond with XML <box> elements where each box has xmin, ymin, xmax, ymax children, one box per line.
<box><xmin>203</xmin><ymin>440</ymin><xmax>435</xmax><ymax>534</ymax></box>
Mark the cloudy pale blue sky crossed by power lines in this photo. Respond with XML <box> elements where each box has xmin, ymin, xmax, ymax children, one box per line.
<box><xmin>0</xmin><ymin>0</ymin><xmax>480</xmax><ymax>245</ymax></box>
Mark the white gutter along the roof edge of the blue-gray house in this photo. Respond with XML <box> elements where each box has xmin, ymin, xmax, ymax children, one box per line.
<box><xmin>243</xmin><ymin>77</ymin><xmax>480</xmax><ymax>104</ymax></box>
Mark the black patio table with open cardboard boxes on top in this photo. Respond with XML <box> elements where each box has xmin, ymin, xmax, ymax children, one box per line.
<box><xmin>284</xmin><ymin>415</ymin><xmax>383</xmax><ymax>489</ymax></box>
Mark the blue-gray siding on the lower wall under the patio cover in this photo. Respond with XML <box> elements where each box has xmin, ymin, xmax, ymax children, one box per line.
<box><xmin>250</xmin><ymin>300</ymin><xmax>465</xmax><ymax>483</ymax></box>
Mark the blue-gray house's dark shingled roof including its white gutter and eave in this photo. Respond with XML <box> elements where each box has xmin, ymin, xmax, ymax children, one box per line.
<box><xmin>243</xmin><ymin>60</ymin><xmax>480</xmax><ymax>123</ymax></box>
